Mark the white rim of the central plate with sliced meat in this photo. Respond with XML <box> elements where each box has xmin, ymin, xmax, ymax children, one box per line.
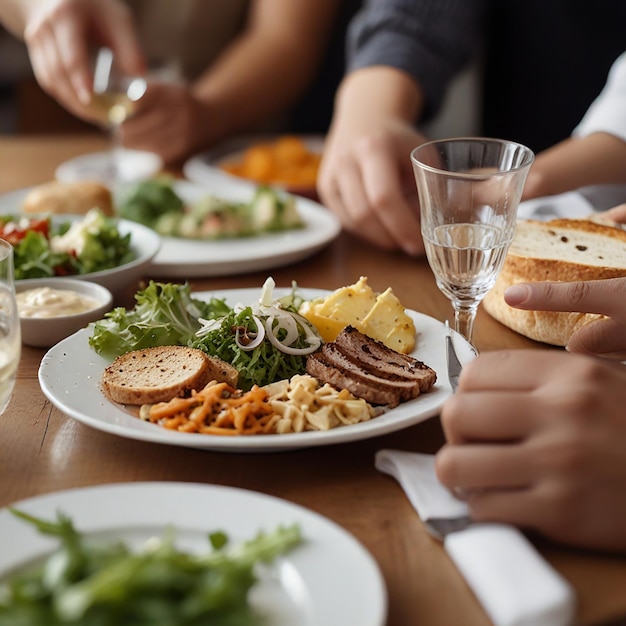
<box><xmin>38</xmin><ymin>287</ymin><xmax>474</xmax><ymax>453</ymax></box>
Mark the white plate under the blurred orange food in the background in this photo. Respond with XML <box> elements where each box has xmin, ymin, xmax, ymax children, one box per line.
<box><xmin>183</xmin><ymin>135</ymin><xmax>324</xmax><ymax>195</ymax></box>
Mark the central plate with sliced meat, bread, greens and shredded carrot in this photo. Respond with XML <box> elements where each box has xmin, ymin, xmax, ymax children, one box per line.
<box><xmin>39</xmin><ymin>283</ymin><xmax>473</xmax><ymax>451</ymax></box>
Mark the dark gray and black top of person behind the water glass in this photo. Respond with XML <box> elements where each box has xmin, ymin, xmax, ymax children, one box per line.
<box><xmin>347</xmin><ymin>0</ymin><xmax>626</xmax><ymax>151</ymax></box>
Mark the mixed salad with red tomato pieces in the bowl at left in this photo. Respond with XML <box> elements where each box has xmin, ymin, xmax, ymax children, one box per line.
<box><xmin>0</xmin><ymin>209</ymin><xmax>135</xmax><ymax>280</ymax></box>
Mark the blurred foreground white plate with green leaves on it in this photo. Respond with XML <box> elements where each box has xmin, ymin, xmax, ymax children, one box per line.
<box><xmin>0</xmin><ymin>482</ymin><xmax>386</xmax><ymax>626</ymax></box>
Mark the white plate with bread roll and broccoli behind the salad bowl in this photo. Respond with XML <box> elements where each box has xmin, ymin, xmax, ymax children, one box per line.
<box><xmin>0</xmin><ymin>176</ymin><xmax>341</xmax><ymax>276</ymax></box>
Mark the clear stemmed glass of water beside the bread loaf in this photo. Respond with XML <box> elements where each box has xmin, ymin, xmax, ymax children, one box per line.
<box><xmin>411</xmin><ymin>137</ymin><xmax>535</xmax><ymax>343</ymax></box>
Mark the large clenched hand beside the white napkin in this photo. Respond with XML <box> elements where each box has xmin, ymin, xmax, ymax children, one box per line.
<box><xmin>437</xmin><ymin>350</ymin><xmax>626</xmax><ymax>551</ymax></box>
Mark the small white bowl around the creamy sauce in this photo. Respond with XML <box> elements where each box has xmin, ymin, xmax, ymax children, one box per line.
<box><xmin>15</xmin><ymin>278</ymin><xmax>113</xmax><ymax>348</ymax></box>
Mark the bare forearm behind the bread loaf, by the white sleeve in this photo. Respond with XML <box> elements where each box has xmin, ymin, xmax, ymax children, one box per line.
<box><xmin>524</xmin><ymin>132</ymin><xmax>626</xmax><ymax>199</ymax></box>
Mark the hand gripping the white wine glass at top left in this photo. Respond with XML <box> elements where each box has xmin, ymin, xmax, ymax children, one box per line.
<box><xmin>24</xmin><ymin>0</ymin><xmax>145</xmax><ymax>119</ymax></box>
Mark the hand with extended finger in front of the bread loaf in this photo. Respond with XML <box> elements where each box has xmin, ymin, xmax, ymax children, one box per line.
<box><xmin>504</xmin><ymin>277</ymin><xmax>626</xmax><ymax>361</ymax></box>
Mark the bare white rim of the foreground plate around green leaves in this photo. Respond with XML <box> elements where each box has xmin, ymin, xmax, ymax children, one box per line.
<box><xmin>0</xmin><ymin>481</ymin><xmax>388</xmax><ymax>626</ymax></box>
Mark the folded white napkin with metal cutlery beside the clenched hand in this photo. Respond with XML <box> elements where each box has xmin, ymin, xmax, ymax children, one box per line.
<box><xmin>376</xmin><ymin>450</ymin><xmax>576</xmax><ymax>626</ymax></box>
